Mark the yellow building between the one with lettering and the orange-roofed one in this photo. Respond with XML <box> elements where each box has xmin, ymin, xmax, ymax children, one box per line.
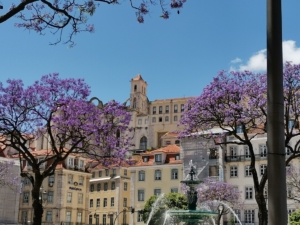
<box><xmin>88</xmin><ymin>165</ymin><xmax>132</xmax><ymax>225</ymax></box>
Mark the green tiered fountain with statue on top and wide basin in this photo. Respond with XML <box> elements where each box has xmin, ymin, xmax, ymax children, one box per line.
<box><xmin>166</xmin><ymin>160</ymin><xmax>218</xmax><ymax>225</ymax></box>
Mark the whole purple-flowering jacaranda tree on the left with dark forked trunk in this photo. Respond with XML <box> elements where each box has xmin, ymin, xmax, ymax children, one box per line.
<box><xmin>0</xmin><ymin>74</ymin><xmax>130</xmax><ymax>225</ymax></box>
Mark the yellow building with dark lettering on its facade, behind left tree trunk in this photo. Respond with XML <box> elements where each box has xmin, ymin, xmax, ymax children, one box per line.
<box><xmin>19</xmin><ymin>150</ymin><xmax>91</xmax><ymax>225</ymax></box>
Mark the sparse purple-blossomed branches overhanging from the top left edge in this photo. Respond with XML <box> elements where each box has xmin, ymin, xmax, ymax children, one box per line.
<box><xmin>0</xmin><ymin>0</ymin><xmax>186</xmax><ymax>45</ymax></box>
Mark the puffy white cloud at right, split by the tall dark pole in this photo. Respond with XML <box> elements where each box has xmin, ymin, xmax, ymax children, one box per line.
<box><xmin>231</xmin><ymin>40</ymin><xmax>300</xmax><ymax>71</ymax></box>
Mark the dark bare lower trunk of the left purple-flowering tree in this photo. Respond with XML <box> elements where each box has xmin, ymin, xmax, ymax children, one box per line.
<box><xmin>31</xmin><ymin>174</ymin><xmax>44</xmax><ymax>225</ymax></box>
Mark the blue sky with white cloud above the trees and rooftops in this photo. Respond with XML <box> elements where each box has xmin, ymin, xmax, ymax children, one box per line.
<box><xmin>0</xmin><ymin>0</ymin><xmax>300</xmax><ymax>102</ymax></box>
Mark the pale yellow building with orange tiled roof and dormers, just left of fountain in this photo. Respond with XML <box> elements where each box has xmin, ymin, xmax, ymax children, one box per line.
<box><xmin>129</xmin><ymin>144</ymin><xmax>182</xmax><ymax>225</ymax></box>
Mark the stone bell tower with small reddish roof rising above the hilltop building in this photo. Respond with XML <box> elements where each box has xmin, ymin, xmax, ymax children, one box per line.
<box><xmin>130</xmin><ymin>74</ymin><xmax>148</xmax><ymax>114</ymax></box>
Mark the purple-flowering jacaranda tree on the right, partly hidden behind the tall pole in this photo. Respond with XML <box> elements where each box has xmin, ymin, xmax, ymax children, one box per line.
<box><xmin>181</xmin><ymin>62</ymin><xmax>300</xmax><ymax>225</ymax></box>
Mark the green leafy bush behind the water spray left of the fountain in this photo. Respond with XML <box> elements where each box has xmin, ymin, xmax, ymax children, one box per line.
<box><xmin>143</xmin><ymin>193</ymin><xmax>188</xmax><ymax>225</ymax></box>
